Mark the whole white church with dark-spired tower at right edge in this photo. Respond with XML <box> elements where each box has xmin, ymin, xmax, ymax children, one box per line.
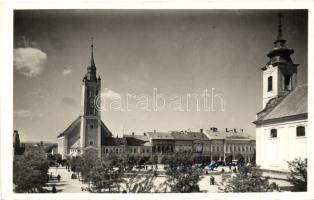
<box><xmin>253</xmin><ymin>15</ymin><xmax>308</xmax><ymax>172</ymax></box>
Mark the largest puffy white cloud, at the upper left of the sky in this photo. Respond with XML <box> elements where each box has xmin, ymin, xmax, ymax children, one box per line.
<box><xmin>14</xmin><ymin>47</ymin><xmax>47</xmax><ymax>77</ymax></box>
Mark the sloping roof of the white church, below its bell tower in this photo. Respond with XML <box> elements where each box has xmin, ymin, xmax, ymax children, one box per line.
<box><xmin>254</xmin><ymin>85</ymin><xmax>308</xmax><ymax>123</ymax></box>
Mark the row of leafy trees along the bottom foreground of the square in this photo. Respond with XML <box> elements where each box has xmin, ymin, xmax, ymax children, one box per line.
<box><xmin>13</xmin><ymin>148</ymin><xmax>307</xmax><ymax>193</ymax></box>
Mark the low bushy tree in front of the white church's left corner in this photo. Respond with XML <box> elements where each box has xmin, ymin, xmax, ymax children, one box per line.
<box><xmin>219</xmin><ymin>165</ymin><xmax>278</xmax><ymax>192</ymax></box>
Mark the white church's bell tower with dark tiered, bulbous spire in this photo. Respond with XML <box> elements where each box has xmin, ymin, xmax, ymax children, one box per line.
<box><xmin>262</xmin><ymin>14</ymin><xmax>298</xmax><ymax>108</ymax></box>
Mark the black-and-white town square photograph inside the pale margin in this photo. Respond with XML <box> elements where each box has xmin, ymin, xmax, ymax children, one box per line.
<box><xmin>1</xmin><ymin>1</ymin><xmax>313</xmax><ymax>199</ymax></box>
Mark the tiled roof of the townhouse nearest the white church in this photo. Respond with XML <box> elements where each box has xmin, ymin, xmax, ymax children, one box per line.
<box><xmin>205</xmin><ymin>130</ymin><xmax>255</xmax><ymax>140</ymax></box>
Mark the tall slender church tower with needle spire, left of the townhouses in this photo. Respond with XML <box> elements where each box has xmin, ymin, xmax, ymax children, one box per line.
<box><xmin>80</xmin><ymin>41</ymin><xmax>101</xmax><ymax>157</ymax></box>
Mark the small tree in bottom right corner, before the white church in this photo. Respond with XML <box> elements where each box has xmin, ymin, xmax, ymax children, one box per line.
<box><xmin>288</xmin><ymin>158</ymin><xmax>307</xmax><ymax>191</ymax></box>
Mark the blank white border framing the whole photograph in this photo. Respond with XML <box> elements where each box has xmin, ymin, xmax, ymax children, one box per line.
<box><xmin>0</xmin><ymin>0</ymin><xmax>314</xmax><ymax>199</ymax></box>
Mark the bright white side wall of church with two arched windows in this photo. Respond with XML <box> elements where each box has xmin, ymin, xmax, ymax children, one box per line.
<box><xmin>256</xmin><ymin>119</ymin><xmax>307</xmax><ymax>171</ymax></box>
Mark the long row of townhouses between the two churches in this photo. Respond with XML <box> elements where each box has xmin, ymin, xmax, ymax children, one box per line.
<box><xmin>98</xmin><ymin>127</ymin><xmax>255</xmax><ymax>162</ymax></box>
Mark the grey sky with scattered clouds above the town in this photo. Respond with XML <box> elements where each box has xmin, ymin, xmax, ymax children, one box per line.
<box><xmin>13</xmin><ymin>10</ymin><xmax>308</xmax><ymax>142</ymax></box>
